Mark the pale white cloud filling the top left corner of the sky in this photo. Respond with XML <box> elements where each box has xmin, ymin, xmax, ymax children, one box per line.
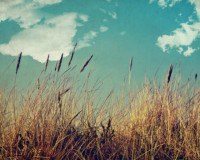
<box><xmin>0</xmin><ymin>0</ymin><xmax>62</xmax><ymax>28</ymax></box>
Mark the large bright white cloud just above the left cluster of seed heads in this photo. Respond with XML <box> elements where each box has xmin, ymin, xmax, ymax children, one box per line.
<box><xmin>0</xmin><ymin>13</ymin><xmax>78</xmax><ymax>62</ymax></box>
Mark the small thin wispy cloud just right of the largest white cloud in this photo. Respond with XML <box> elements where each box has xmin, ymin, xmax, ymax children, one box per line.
<box><xmin>78</xmin><ymin>31</ymin><xmax>98</xmax><ymax>49</ymax></box>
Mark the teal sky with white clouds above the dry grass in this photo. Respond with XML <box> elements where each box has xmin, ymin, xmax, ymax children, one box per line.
<box><xmin>0</xmin><ymin>0</ymin><xmax>200</xmax><ymax>89</ymax></box>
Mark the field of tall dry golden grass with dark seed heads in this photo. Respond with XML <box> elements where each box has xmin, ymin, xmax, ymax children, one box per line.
<box><xmin>0</xmin><ymin>52</ymin><xmax>200</xmax><ymax>160</ymax></box>
